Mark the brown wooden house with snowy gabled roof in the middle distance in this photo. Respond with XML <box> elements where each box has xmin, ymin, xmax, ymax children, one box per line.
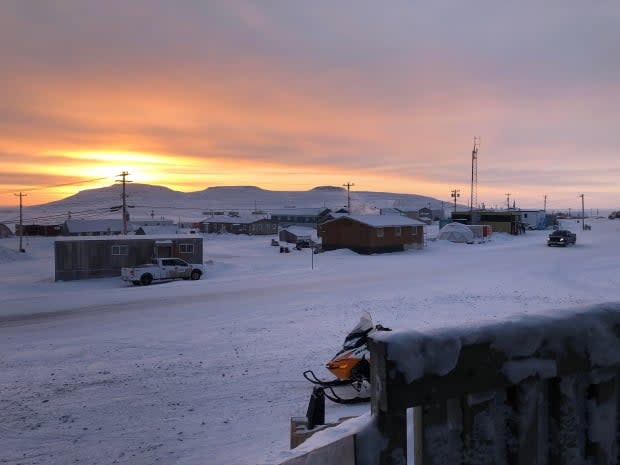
<box><xmin>318</xmin><ymin>215</ymin><xmax>424</xmax><ymax>253</ymax></box>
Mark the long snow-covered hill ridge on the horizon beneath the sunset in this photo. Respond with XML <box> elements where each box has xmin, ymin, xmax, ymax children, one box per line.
<box><xmin>0</xmin><ymin>183</ymin><xmax>450</xmax><ymax>225</ymax></box>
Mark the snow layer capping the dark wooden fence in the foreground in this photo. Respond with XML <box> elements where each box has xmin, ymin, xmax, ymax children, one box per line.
<box><xmin>373</xmin><ymin>303</ymin><xmax>620</xmax><ymax>383</ymax></box>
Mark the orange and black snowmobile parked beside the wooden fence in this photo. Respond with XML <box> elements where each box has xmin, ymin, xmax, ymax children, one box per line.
<box><xmin>303</xmin><ymin>312</ymin><xmax>391</xmax><ymax>404</ymax></box>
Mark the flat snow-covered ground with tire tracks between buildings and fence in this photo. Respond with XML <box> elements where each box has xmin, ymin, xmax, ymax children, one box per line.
<box><xmin>0</xmin><ymin>219</ymin><xmax>620</xmax><ymax>465</ymax></box>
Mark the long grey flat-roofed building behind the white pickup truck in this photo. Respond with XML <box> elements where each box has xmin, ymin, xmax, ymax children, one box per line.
<box><xmin>54</xmin><ymin>235</ymin><xmax>203</xmax><ymax>281</ymax></box>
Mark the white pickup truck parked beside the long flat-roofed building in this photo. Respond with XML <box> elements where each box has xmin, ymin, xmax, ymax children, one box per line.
<box><xmin>121</xmin><ymin>258</ymin><xmax>204</xmax><ymax>286</ymax></box>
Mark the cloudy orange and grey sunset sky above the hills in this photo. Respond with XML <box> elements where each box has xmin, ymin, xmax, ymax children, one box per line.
<box><xmin>0</xmin><ymin>0</ymin><xmax>620</xmax><ymax>209</ymax></box>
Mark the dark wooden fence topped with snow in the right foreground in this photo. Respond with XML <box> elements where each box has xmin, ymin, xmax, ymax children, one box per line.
<box><xmin>370</xmin><ymin>303</ymin><xmax>620</xmax><ymax>465</ymax></box>
